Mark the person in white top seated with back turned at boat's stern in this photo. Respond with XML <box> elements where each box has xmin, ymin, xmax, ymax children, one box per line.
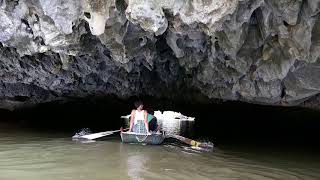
<box><xmin>129</xmin><ymin>101</ymin><xmax>150</xmax><ymax>134</ymax></box>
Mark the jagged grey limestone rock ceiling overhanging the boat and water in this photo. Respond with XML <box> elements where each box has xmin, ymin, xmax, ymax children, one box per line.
<box><xmin>0</xmin><ymin>0</ymin><xmax>320</xmax><ymax>108</ymax></box>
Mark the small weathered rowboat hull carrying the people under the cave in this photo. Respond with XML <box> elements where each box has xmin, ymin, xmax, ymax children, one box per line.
<box><xmin>120</xmin><ymin>132</ymin><xmax>165</xmax><ymax>145</ymax></box>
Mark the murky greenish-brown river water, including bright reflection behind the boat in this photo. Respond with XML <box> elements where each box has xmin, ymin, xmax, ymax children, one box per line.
<box><xmin>0</xmin><ymin>118</ymin><xmax>320</xmax><ymax>180</ymax></box>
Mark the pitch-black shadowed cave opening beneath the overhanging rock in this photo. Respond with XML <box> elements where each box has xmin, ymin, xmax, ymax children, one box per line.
<box><xmin>0</xmin><ymin>97</ymin><xmax>320</xmax><ymax>148</ymax></box>
